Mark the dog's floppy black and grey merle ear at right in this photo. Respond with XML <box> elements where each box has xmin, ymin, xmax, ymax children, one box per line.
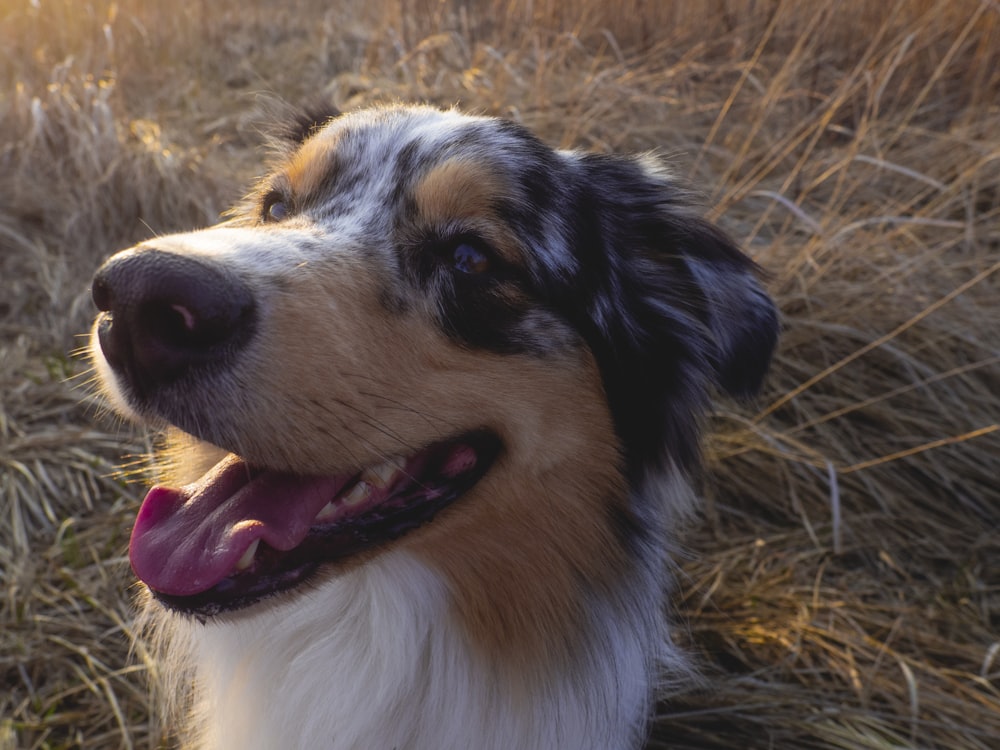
<box><xmin>574</xmin><ymin>155</ymin><xmax>778</xmax><ymax>478</ymax></box>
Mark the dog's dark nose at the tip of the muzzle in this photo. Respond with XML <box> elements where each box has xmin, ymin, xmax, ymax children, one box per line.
<box><xmin>92</xmin><ymin>248</ymin><xmax>256</xmax><ymax>397</ymax></box>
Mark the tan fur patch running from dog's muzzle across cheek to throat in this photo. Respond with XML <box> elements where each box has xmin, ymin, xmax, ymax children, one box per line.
<box><xmin>219</xmin><ymin>262</ymin><xmax>626</xmax><ymax>667</ymax></box>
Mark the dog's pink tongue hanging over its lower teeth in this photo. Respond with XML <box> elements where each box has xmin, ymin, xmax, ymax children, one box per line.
<box><xmin>129</xmin><ymin>456</ymin><xmax>350</xmax><ymax>596</ymax></box>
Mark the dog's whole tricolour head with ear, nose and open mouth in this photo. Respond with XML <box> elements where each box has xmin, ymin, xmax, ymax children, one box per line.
<box><xmin>92</xmin><ymin>107</ymin><xmax>777</xmax><ymax>624</ymax></box>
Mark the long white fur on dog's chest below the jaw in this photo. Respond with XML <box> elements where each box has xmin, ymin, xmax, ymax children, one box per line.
<box><xmin>147</xmin><ymin>550</ymin><xmax>682</xmax><ymax>750</ymax></box>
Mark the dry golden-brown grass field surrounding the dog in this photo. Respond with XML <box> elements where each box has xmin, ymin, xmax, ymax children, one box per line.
<box><xmin>0</xmin><ymin>0</ymin><xmax>1000</xmax><ymax>750</ymax></box>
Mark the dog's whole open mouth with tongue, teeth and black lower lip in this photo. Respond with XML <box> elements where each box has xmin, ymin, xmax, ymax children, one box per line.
<box><xmin>129</xmin><ymin>432</ymin><xmax>500</xmax><ymax>616</ymax></box>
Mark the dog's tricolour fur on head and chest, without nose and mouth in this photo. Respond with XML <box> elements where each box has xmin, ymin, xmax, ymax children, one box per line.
<box><xmin>92</xmin><ymin>107</ymin><xmax>777</xmax><ymax>750</ymax></box>
